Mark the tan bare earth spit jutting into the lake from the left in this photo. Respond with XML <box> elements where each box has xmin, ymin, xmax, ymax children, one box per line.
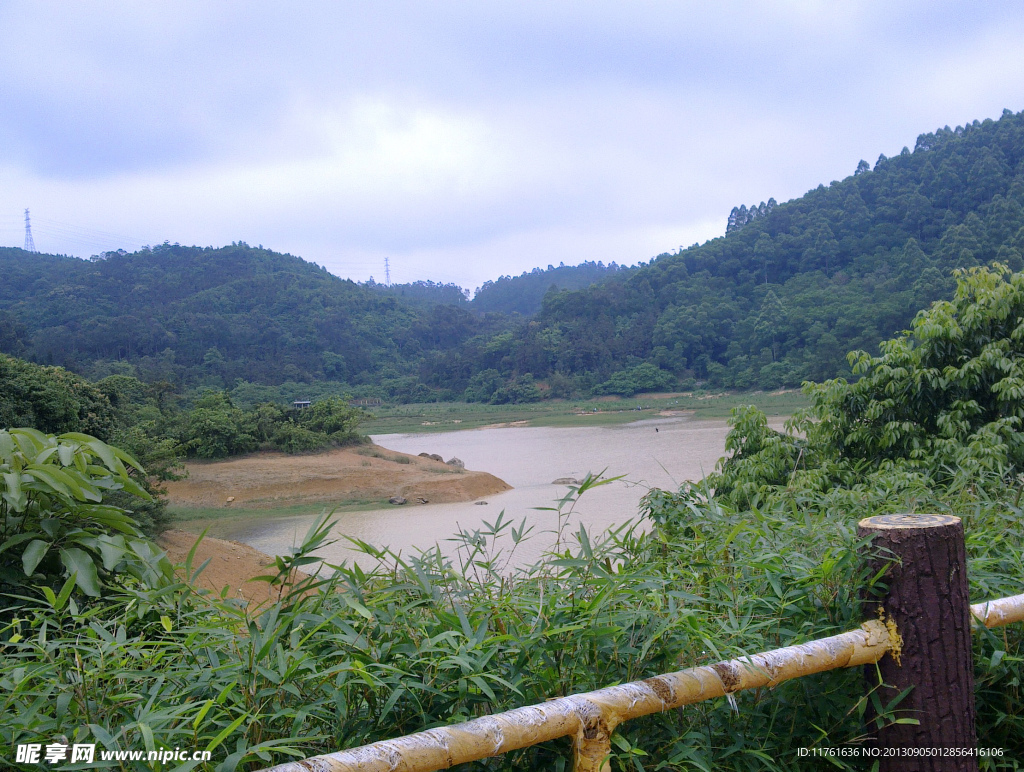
<box><xmin>167</xmin><ymin>445</ymin><xmax>511</xmax><ymax>509</ymax></box>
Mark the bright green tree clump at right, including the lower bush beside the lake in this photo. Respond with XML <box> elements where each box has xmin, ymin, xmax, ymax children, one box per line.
<box><xmin>709</xmin><ymin>264</ymin><xmax>1024</xmax><ymax>505</ymax></box>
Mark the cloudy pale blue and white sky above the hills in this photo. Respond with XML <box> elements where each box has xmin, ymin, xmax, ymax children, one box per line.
<box><xmin>0</xmin><ymin>0</ymin><xmax>1024</xmax><ymax>289</ymax></box>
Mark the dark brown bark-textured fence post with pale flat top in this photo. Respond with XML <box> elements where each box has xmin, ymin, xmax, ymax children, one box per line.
<box><xmin>857</xmin><ymin>515</ymin><xmax>978</xmax><ymax>772</ymax></box>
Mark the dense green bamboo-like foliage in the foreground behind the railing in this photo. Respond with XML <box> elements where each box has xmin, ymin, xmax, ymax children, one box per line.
<box><xmin>0</xmin><ymin>478</ymin><xmax>1024</xmax><ymax>772</ymax></box>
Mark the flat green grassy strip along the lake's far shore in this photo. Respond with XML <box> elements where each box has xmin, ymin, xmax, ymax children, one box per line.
<box><xmin>361</xmin><ymin>390</ymin><xmax>808</xmax><ymax>434</ymax></box>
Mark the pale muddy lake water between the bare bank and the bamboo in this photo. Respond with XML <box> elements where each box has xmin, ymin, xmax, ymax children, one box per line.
<box><xmin>229</xmin><ymin>417</ymin><xmax>761</xmax><ymax>564</ymax></box>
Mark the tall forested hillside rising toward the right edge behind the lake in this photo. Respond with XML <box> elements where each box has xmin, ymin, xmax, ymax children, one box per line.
<box><xmin>508</xmin><ymin>112</ymin><xmax>1024</xmax><ymax>387</ymax></box>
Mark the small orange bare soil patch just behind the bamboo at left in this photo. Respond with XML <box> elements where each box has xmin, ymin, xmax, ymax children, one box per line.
<box><xmin>157</xmin><ymin>530</ymin><xmax>304</xmax><ymax>604</ymax></box>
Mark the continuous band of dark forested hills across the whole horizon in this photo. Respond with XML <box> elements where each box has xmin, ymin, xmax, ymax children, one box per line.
<box><xmin>6</xmin><ymin>111</ymin><xmax>1024</xmax><ymax>402</ymax></box>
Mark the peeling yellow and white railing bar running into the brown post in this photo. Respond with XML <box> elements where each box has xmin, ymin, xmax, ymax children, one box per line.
<box><xmin>258</xmin><ymin>594</ymin><xmax>1024</xmax><ymax>772</ymax></box>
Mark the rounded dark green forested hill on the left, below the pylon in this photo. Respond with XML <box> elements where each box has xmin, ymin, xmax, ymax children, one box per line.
<box><xmin>0</xmin><ymin>244</ymin><xmax>505</xmax><ymax>398</ymax></box>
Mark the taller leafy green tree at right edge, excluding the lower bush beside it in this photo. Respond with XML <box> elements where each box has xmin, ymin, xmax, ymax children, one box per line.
<box><xmin>809</xmin><ymin>264</ymin><xmax>1024</xmax><ymax>475</ymax></box>
